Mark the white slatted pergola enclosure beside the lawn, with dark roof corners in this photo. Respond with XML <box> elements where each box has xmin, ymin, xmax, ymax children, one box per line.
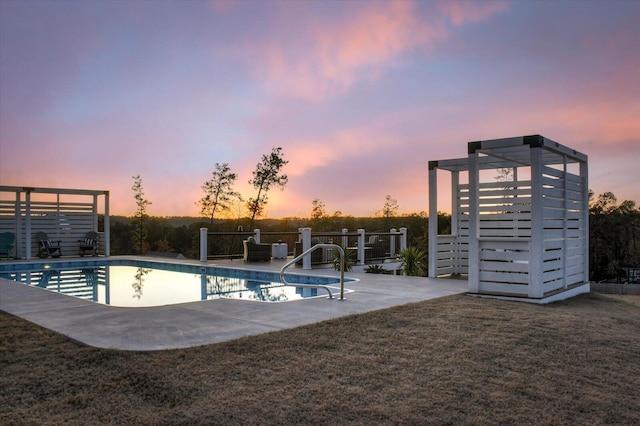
<box><xmin>429</xmin><ymin>135</ymin><xmax>589</xmax><ymax>303</ymax></box>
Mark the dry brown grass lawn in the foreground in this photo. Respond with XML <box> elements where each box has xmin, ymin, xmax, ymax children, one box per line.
<box><xmin>0</xmin><ymin>294</ymin><xmax>640</xmax><ymax>425</ymax></box>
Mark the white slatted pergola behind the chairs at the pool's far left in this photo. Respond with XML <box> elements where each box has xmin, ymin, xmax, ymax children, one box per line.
<box><xmin>0</xmin><ymin>186</ymin><xmax>110</xmax><ymax>259</ymax></box>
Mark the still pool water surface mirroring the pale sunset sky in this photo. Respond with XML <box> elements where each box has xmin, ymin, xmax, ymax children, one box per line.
<box><xmin>0</xmin><ymin>266</ymin><xmax>336</xmax><ymax>307</ymax></box>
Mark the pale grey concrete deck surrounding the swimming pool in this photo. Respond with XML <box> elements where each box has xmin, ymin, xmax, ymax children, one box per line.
<box><xmin>0</xmin><ymin>258</ymin><xmax>467</xmax><ymax>351</ymax></box>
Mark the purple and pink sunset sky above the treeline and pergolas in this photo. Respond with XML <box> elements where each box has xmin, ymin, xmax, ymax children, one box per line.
<box><xmin>0</xmin><ymin>0</ymin><xmax>640</xmax><ymax>218</ymax></box>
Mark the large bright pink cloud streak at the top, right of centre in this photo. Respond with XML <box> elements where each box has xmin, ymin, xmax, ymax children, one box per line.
<box><xmin>238</xmin><ymin>1</ymin><xmax>505</xmax><ymax>101</ymax></box>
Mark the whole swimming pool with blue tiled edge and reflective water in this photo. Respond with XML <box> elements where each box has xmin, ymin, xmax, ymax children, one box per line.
<box><xmin>0</xmin><ymin>258</ymin><xmax>353</xmax><ymax>307</ymax></box>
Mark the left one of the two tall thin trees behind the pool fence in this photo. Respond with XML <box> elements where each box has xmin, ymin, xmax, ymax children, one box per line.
<box><xmin>196</xmin><ymin>163</ymin><xmax>241</xmax><ymax>230</ymax></box>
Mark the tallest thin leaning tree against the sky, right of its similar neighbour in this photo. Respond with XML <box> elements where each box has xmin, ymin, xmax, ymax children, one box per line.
<box><xmin>247</xmin><ymin>147</ymin><xmax>289</xmax><ymax>229</ymax></box>
